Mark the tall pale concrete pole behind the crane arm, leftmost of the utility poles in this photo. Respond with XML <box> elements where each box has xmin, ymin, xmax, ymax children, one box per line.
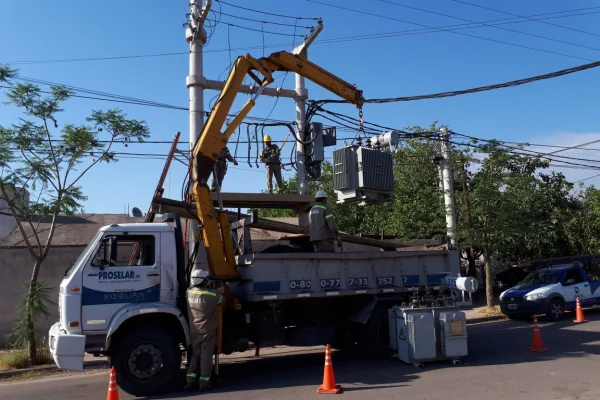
<box><xmin>185</xmin><ymin>0</ymin><xmax>212</xmax><ymax>270</ymax></box>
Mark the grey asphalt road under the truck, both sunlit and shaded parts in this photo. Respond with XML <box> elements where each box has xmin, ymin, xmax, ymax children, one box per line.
<box><xmin>0</xmin><ymin>313</ymin><xmax>600</xmax><ymax>400</ymax></box>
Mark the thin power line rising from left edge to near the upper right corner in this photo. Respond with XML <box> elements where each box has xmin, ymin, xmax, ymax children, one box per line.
<box><xmin>3</xmin><ymin>7</ymin><xmax>600</xmax><ymax>65</ymax></box>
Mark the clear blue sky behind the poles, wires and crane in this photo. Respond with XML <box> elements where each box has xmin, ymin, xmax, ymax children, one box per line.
<box><xmin>0</xmin><ymin>0</ymin><xmax>600</xmax><ymax>213</ymax></box>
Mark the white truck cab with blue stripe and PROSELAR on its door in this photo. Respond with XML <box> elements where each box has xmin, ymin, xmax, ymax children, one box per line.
<box><xmin>49</xmin><ymin>220</ymin><xmax>189</xmax><ymax>396</ymax></box>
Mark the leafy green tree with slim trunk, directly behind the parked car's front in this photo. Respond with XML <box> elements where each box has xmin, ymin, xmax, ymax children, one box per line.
<box><xmin>459</xmin><ymin>141</ymin><xmax>577</xmax><ymax>306</ymax></box>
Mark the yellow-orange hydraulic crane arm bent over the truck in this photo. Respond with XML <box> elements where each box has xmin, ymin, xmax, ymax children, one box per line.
<box><xmin>192</xmin><ymin>51</ymin><xmax>364</xmax><ymax>280</ymax></box>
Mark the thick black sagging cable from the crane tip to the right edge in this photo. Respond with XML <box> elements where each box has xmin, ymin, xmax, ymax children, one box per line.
<box><xmin>316</xmin><ymin>58</ymin><xmax>600</xmax><ymax>104</ymax></box>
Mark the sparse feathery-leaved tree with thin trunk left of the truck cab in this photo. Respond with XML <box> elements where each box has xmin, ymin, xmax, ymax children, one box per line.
<box><xmin>0</xmin><ymin>66</ymin><xmax>149</xmax><ymax>365</ymax></box>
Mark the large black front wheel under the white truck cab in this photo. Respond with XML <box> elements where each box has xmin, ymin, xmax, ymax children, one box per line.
<box><xmin>111</xmin><ymin>327</ymin><xmax>181</xmax><ymax>396</ymax></box>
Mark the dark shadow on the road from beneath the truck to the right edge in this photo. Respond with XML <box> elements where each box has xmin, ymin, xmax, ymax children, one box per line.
<box><xmin>136</xmin><ymin>311</ymin><xmax>600</xmax><ymax>400</ymax></box>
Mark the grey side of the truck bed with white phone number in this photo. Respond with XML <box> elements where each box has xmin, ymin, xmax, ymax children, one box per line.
<box><xmin>230</xmin><ymin>250</ymin><xmax>460</xmax><ymax>301</ymax></box>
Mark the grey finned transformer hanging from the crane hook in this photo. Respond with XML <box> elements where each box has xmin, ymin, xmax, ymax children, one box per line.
<box><xmin>333</xmin><ymin>146</ymin><xmax>394</xmax><ymax>205</ymax></box>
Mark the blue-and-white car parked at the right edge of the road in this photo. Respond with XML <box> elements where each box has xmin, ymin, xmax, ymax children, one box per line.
<box><xmin>500</xmin><ymin>266</ymin><xmax>600</xmax><ymax>320</ymax></box>
